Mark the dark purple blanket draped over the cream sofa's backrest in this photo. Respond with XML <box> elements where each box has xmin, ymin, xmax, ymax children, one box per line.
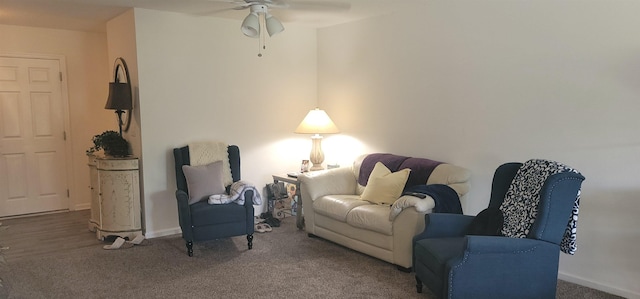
<box><xmin>358</xmin><ymin>153</ymin><xmax>442</xmax><ymax>189</ymax></box>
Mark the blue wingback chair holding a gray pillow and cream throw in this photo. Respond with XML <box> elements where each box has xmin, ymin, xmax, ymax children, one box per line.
<box><xmin>173</xmin><ymin>145</ymin><xmax>254</xmax><ymax>256</ymax></box>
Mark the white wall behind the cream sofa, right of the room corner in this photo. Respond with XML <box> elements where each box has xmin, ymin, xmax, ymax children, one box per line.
<box><xmin>318</xmin><ymin>1</ymin><xmax>640</xmax><ymax>298</ymax></box>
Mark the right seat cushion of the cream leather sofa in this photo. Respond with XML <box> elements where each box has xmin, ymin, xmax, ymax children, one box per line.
<box><xmin>347</xmin><ymin>204</ymin><xmax>393</xmax><ymax>236</ymax></box>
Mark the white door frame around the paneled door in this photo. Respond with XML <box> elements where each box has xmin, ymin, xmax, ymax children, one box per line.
<box><xmin>0</xmin><ymin>51</ymin><xmax>75</xmax><ymax>213</ymax></box>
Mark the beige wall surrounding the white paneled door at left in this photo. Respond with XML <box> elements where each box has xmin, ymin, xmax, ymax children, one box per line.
<box><xmin>0</xmin><ymin>25</ymin><xmax>112</xmax><ymax>210</ymax></box>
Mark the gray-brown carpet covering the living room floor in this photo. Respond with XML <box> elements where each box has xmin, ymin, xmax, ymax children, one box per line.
<box><xmin>0</xmin><ymin>217</ymin><xmax>617</xmax><ymax>298</ymax></box>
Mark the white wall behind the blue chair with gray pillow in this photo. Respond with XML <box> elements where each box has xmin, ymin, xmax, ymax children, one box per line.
<box><xmin>135</xmin><ymin>9</ymin><xmax>317</xmax><ymax>237</ymax></box>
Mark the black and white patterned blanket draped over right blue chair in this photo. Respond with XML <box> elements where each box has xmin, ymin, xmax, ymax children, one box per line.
<box><xmin>500</xmin><ymin>159</ymin><xmax>580</xmax><ymax>254</ymax></box>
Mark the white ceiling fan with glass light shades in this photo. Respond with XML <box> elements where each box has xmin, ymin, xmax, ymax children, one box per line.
<box><xmin>210</xmin><ymin>0</ymin><xmax>351</xmax><ymax>38</ymax></box>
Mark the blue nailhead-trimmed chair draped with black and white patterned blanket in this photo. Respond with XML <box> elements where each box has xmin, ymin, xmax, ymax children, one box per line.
<box><xmin>413</xmin><ymin>163</ymin><xmax>584</xmax><ymax>299</ymax></box>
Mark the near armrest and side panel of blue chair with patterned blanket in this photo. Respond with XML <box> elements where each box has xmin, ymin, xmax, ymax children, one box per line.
<box><xmin>446</xmin><ymin>236</ymin><xmax>560</xmax><ymax>298</ymax></box>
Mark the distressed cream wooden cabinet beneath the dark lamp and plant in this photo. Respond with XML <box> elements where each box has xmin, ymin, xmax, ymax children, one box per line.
<box><xmin>89</xmin><ymin>155</ymin><xmax>142</xmax><ymax>240</ymax></box>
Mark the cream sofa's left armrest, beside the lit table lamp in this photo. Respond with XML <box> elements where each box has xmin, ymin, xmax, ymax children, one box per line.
<box><xmin>298</xmin><ymin>167</ymin><xmax>357</xmax><ymax>200</ymax></box>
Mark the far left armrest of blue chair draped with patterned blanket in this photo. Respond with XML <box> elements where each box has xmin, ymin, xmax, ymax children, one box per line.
<box><xmin>413</xmin><ymin>213</ymin><xmax>474</xmax><ymax>243</ymax></box>
